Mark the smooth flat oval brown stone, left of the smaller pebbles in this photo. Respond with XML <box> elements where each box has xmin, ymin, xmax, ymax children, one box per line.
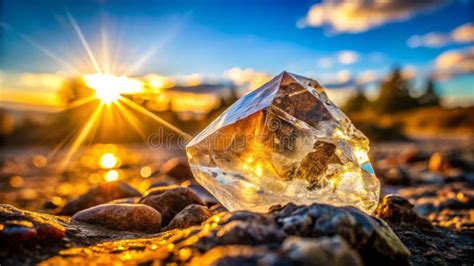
<box><xmin>72</xmin><ymin>204</ymin><xmax>161</xmax><ymax>233</ymax></box>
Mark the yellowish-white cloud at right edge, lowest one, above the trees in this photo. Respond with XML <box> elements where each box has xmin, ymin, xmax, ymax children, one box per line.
<box><xmin>433</xmin><ymin>46</ymin><xmax>474</xmax><ymax>79</ymax></box>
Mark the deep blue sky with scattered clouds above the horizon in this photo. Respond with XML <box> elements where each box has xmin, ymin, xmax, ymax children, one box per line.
<box><xmin>0</xmin><ymin>0</ymin><xmax>474</xmax><ymax>106</ymax></box>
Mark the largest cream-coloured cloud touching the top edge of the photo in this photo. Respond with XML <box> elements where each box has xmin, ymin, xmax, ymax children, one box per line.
<box><xmin>297</xmin><ymin>0</ymin><xmax>445</xmax><ymax>32</ymax></box>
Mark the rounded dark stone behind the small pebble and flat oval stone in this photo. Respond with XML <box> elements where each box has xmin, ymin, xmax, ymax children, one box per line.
<box><xmin>140</xmin><ymin>187</ymin><xmax>205</xmax><ymax>225</ymax></box>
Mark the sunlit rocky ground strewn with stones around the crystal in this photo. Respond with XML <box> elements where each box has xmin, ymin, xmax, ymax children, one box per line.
<box><xmin>0</xmin><ymin>139</ymin><xmax>474</xmax><ymax>265</ymax></box>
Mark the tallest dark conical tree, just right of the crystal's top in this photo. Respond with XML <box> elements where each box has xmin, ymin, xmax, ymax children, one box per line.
<box><xmin>375</xmin><ymin>68</ymin><xmax>419</xmax><ymax>113</ymax></box>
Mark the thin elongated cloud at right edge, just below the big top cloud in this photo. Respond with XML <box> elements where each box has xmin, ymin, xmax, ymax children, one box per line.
<box><xmin>407</xmin><ymin>23</ymin><xmax>474</xmax><ymax>48</ymax></box>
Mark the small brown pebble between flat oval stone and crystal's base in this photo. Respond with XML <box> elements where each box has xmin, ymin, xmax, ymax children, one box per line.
<box><xmin>165</xmin><ymin>204</ymin><xmax>211</xmax><ymax>230</ymax></box>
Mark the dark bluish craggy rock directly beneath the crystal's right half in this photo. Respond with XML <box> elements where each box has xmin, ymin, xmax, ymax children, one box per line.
<box><xmin>274</xmin><ymin>204</ymin><xmax>410</xmax><ymax>263</ymax></box>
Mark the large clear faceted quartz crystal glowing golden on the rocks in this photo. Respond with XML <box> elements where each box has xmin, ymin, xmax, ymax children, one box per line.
<box><xmin>186</xmin><ymin>72</ymin><xmax>380</xmax><ymax>213</ymax></box>
